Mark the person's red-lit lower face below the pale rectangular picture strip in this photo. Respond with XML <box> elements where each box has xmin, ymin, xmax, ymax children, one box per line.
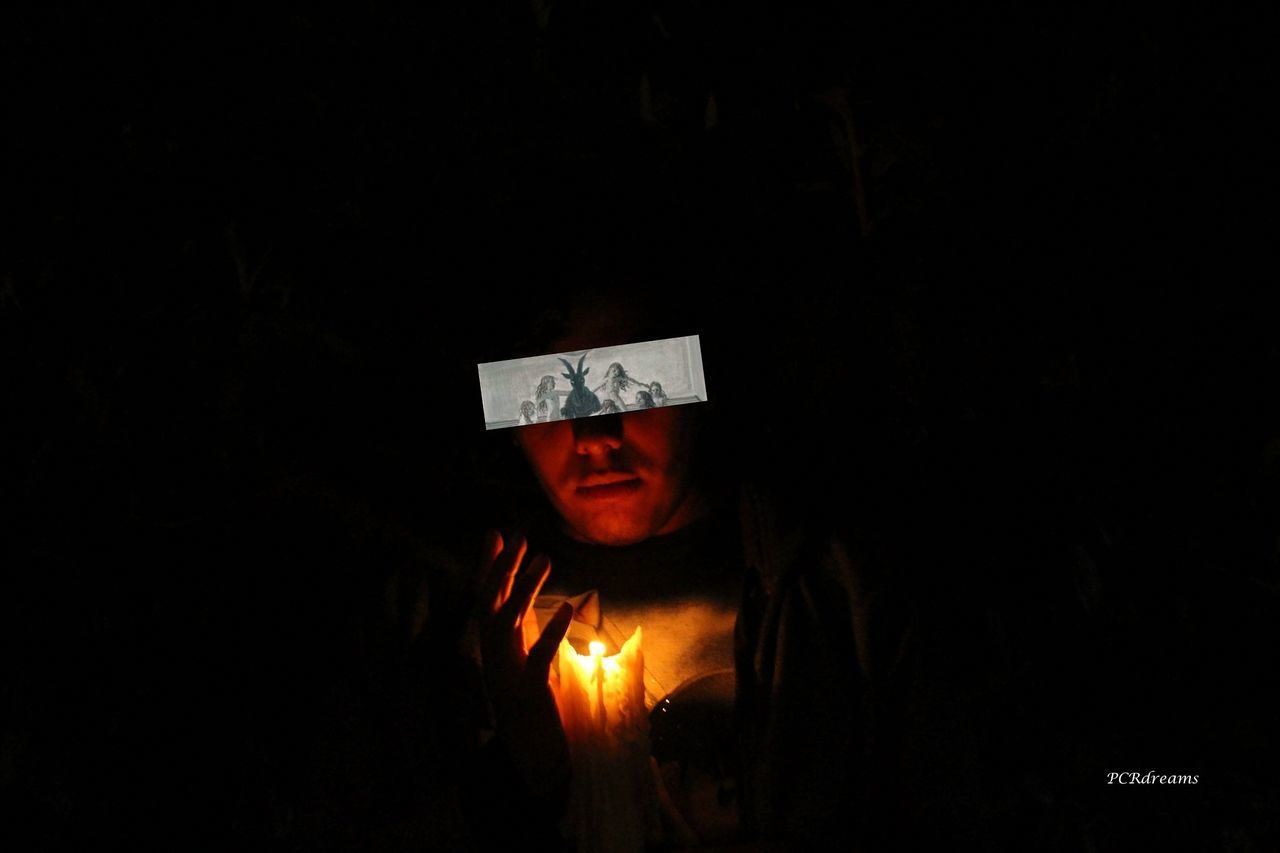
<box><xmin>516</xmin><ymin>407</ymin><xmax>701</xmax><ymax>546</ymax></box>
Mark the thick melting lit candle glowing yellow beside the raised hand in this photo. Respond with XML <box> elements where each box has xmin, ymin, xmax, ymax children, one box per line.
<box><xmin>553</xmin><ymin>628</ymin><xmax>660</xmax><ymax>853</ymax></box>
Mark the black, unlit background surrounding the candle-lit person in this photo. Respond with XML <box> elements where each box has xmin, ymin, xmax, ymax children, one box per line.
<box><xmin>0</xmin><ymin>3</ymin><xmax>1280</xmax><ymax>849</ymax></box>
